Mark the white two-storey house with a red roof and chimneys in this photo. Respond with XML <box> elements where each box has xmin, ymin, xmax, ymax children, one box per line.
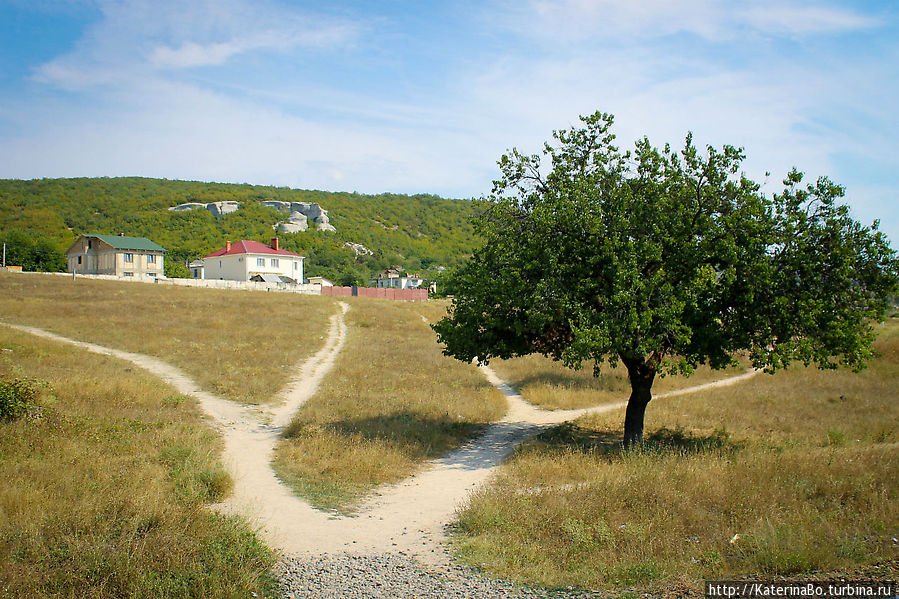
<box><xmin>191</xmin><ymin>237</ymin><xmax>305</xmax><ymax>283</ymax></box>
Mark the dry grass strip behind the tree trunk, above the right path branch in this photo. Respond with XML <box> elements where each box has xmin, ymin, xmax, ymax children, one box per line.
<box><xmin>490</xmin><ymin>355</ymin><xmax>746</xmax><ymax>410</ymax></box>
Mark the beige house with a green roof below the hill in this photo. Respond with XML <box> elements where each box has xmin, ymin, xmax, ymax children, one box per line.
<box><xmin>66</xmin><ymin>233</ymin><xmax>166</xmax><ymax>279</ymax></box>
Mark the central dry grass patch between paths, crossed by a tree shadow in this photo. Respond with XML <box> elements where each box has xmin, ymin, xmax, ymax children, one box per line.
<box><xmin>274</xmin><ymin>298</ymin><xmax>505</xmax><ymax>511</ymax></box>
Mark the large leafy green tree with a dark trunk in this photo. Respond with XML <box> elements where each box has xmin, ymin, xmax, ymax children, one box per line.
<box><xmin>434</xmin><ymin>112</ymin><xmax>899</xmax><ymax>445</ymax></box>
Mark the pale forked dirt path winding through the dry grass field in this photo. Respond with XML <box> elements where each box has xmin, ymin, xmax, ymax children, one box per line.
<box><xmin>6</xmin><ymin>310</ymin><xmax>757</xmax><ymax>564</ymax></box>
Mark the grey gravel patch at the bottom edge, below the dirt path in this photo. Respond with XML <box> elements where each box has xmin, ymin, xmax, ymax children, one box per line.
<box><xmin>275</xmin><ymin>553</ymin><xmax>598</xmax><ymax>599</ymax></box>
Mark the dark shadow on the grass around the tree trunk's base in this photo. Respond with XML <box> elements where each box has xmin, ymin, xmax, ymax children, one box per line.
<box><xmin>519</xmin><ymin>422</ymin><xmax>742</xmax><ymax>461</ymax></box>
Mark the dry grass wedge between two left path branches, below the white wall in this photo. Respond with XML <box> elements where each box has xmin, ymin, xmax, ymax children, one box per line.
<box><xmin>0</xmin><ymin>273</ymin><xmax>337</xmax><ymax>403</ymax></box>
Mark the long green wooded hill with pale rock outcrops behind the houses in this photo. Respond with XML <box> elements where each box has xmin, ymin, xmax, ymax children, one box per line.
<box><xmin>0</xmin><ymin>177</ymin><xmax>486</xmax><ymax>283</ymax></box>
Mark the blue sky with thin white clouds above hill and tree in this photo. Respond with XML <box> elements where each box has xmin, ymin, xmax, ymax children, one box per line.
<box><xmin>0</xmin><ymin>0</ymin><xmax>899</xmax><ymax>248</ymax></box>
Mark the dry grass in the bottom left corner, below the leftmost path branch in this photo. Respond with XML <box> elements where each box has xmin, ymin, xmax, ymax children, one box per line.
<box><xmin>0</xmin><ymin>328</ymin><xmax>274</xmax><ymax>598</ymax></box>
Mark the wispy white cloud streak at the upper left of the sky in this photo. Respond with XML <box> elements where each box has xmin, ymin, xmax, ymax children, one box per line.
<box><xmin>35</xmin><ymin>0</ymin><xmax>359</xmax><ymax>89</ymax></box>
